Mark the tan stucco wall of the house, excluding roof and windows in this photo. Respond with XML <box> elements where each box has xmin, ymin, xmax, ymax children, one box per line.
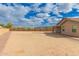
<box><xmin>61</xmin><ymin>21</ymin><xmax>79</xmax><ymax>37</ymax></box>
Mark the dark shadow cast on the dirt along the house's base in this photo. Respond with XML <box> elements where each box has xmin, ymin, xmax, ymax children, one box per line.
<box><xmin>44</xmin><ymin>32</ymin><xmax>79</xmax><ymax>42</ymax></box>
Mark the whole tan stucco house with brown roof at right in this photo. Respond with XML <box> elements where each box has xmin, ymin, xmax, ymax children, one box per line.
<box><xmin>55</xmin><ymin>18</ymin><xmax>79</xmax><ymax>37</ymax></box>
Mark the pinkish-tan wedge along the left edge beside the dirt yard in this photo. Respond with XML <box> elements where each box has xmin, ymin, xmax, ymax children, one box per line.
<box><xmin>0</xmin><ymin>28</ymin><xmax>10</xmax><ymax>54</ymax></box>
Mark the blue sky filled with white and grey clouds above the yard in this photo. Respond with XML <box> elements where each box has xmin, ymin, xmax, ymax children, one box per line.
<box><xmin>0</xmin><ymin>3</ymin><xmax>79</xmax><ymax>27</ymax></box>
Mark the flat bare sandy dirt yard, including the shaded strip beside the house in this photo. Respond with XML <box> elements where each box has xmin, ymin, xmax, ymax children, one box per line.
<box><xmin>1</xmin><ymin>31</ymin><xmax>79</xmax><ymax>56</ymax></box>
